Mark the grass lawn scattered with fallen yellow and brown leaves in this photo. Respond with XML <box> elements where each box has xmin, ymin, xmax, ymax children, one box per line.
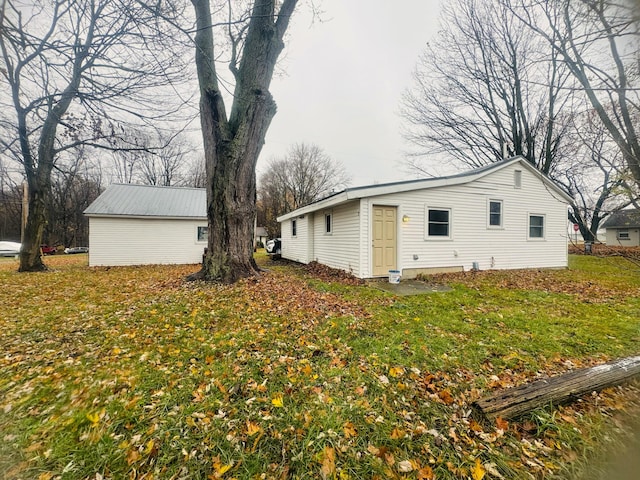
<box><xmin>0</xmin><ymin>255</ymin><xmax>640</xmax><ymax>480</ymax></box>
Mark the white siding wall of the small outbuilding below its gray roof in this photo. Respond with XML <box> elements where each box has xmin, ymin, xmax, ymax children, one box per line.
<box><xmin>89</xmin><ymin>217</ymin><xmax>207</xmax><ymax>266</ymax></box>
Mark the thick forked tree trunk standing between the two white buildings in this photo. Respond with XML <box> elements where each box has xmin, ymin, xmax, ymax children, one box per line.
<box><xmin>191</xmin><ymin>0</ymin><xmax>297</xmax><ymax>283</ymax></box>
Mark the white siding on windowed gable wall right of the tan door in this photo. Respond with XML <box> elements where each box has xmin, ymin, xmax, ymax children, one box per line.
<box><xmin>362</xmin><ymin>161</ymin><xmax>568</xmax><ymax>270</ymax></box>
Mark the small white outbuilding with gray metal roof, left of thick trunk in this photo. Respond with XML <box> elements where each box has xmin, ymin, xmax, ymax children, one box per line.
<box><xmin>84</xmin><ymin>184</ymin><xmax>207</xmax><ymax>266</ymax></box>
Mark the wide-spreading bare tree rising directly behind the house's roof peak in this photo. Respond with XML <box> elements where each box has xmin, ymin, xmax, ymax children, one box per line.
<box><xmin>402</xmin><ymin>0</ymin><xmax>569</xmax><ymax>173</ymax></box>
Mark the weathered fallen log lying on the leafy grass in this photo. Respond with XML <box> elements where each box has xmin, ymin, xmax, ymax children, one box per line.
<box><xmin>473</xmin><ymin>356</ymin><xmax>640</xmax><ymax>420</ymax></box>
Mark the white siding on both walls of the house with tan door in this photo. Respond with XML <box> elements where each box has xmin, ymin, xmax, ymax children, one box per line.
<box><xmin>281</xmin><ymin>160</ymin><xmax>568</xmax><ymax>278</ymax></box>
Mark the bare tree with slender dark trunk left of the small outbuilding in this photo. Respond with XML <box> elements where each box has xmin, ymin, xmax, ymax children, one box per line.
<box><xmin>0</xmin><ymin>0</ymin><xmax>189</xmax><ymax>271</ymax></box>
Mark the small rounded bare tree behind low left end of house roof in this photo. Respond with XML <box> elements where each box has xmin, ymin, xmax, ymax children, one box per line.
<box><xmin>258</xmin><ymin>143</ymin><xmax>349</xmax><ymax>236</ymax></box>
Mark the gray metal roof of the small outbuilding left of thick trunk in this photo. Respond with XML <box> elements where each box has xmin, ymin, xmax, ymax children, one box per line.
<box><xmin>84</xmin><ymin>184</ymin><xmax>207</xmax><ymax>218</ymax></box>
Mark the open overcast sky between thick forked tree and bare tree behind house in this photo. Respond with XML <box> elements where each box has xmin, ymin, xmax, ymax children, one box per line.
<box><xmin>258</xmin><ymin>0</ymin><xmax>440</xmax><ymax>186</ymax></box>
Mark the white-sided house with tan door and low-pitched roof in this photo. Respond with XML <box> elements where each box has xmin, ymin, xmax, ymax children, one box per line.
<box><xmin>278</xmin><ymin>156</ymin><xmax>571</xmax><ymax>278</ymax></box>
